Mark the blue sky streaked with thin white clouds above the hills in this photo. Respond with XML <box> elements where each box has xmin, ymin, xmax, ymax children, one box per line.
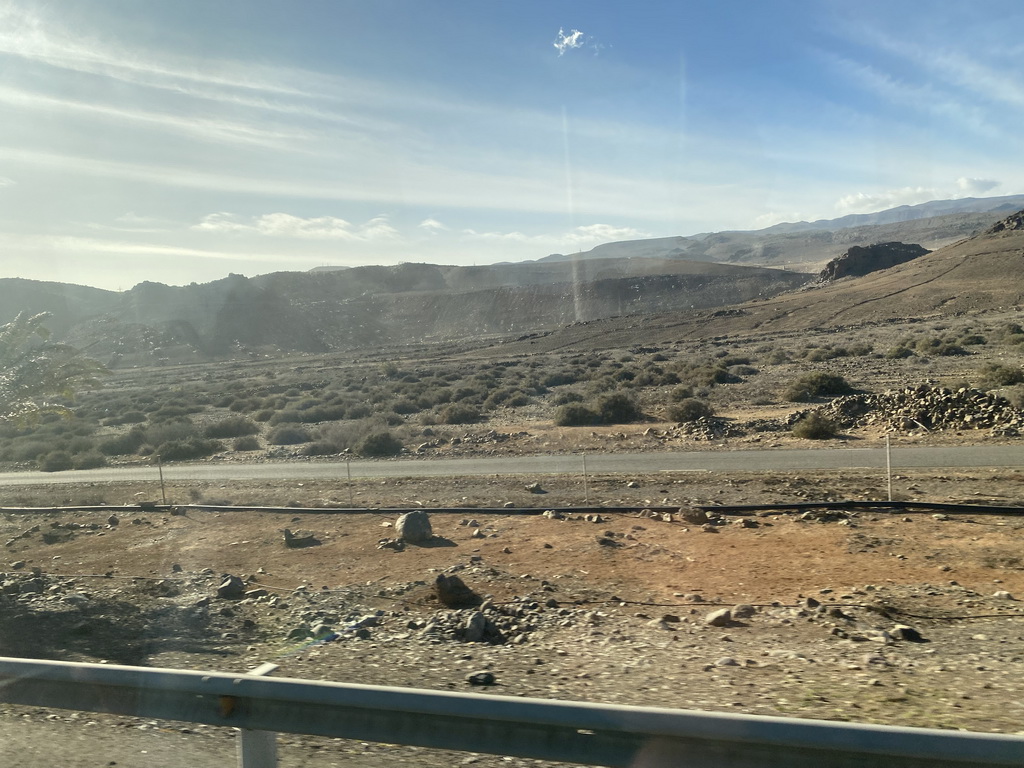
<box><xmin>0</xmin><ymin>0</ymin><xmax>1024</xmax><ymax>290</ymax></box>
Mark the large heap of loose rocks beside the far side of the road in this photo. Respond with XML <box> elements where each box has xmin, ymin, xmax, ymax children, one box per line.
<box><xmin>811</xmin><ymin>384</ymin><xmax>1024</xmax><ymax>436</ymax></box>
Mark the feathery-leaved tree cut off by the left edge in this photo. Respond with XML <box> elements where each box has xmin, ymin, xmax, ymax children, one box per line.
<box><xmin>0</xmin><ymin>312</ymin><xmax>105</xmax><ymax>422</ymax></box>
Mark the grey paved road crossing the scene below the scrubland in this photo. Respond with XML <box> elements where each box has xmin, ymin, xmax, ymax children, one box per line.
<box><xmin>0</xmin><ymin>444</ymin><xmax>1024</xmax><ymax>486</ymax></box>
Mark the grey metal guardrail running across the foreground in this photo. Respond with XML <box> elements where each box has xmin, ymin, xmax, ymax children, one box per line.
<box><xmin>0</xmin><ymin>657</ymin><xmax>1024</xmax><ymax>768</ymax></box>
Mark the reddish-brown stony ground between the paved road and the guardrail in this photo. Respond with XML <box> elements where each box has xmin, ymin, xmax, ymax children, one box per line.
<box><xmin>0</xmin><ymin>469</ymin><xmax>1024</xmax><ymax>766</ymax></box>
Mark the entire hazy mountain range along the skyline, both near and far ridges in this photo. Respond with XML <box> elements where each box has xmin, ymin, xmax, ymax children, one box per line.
<box><xmin>0</xmin><ymin>196</ymin><xmax>1024</xmax><ymax>367</ymax></box>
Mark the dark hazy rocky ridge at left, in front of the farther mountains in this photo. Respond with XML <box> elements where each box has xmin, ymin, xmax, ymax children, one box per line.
<box><xmin>0</xmin><ymin>259</ymin><xmax>810</xmax><ymax>367</ymax></box>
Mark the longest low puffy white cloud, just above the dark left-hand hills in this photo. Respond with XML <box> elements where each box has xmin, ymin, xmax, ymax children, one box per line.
<box><xmin>191</xmin><ymin>213</ymin><xmax>398</xmax><ymax>242</ymax></box>
